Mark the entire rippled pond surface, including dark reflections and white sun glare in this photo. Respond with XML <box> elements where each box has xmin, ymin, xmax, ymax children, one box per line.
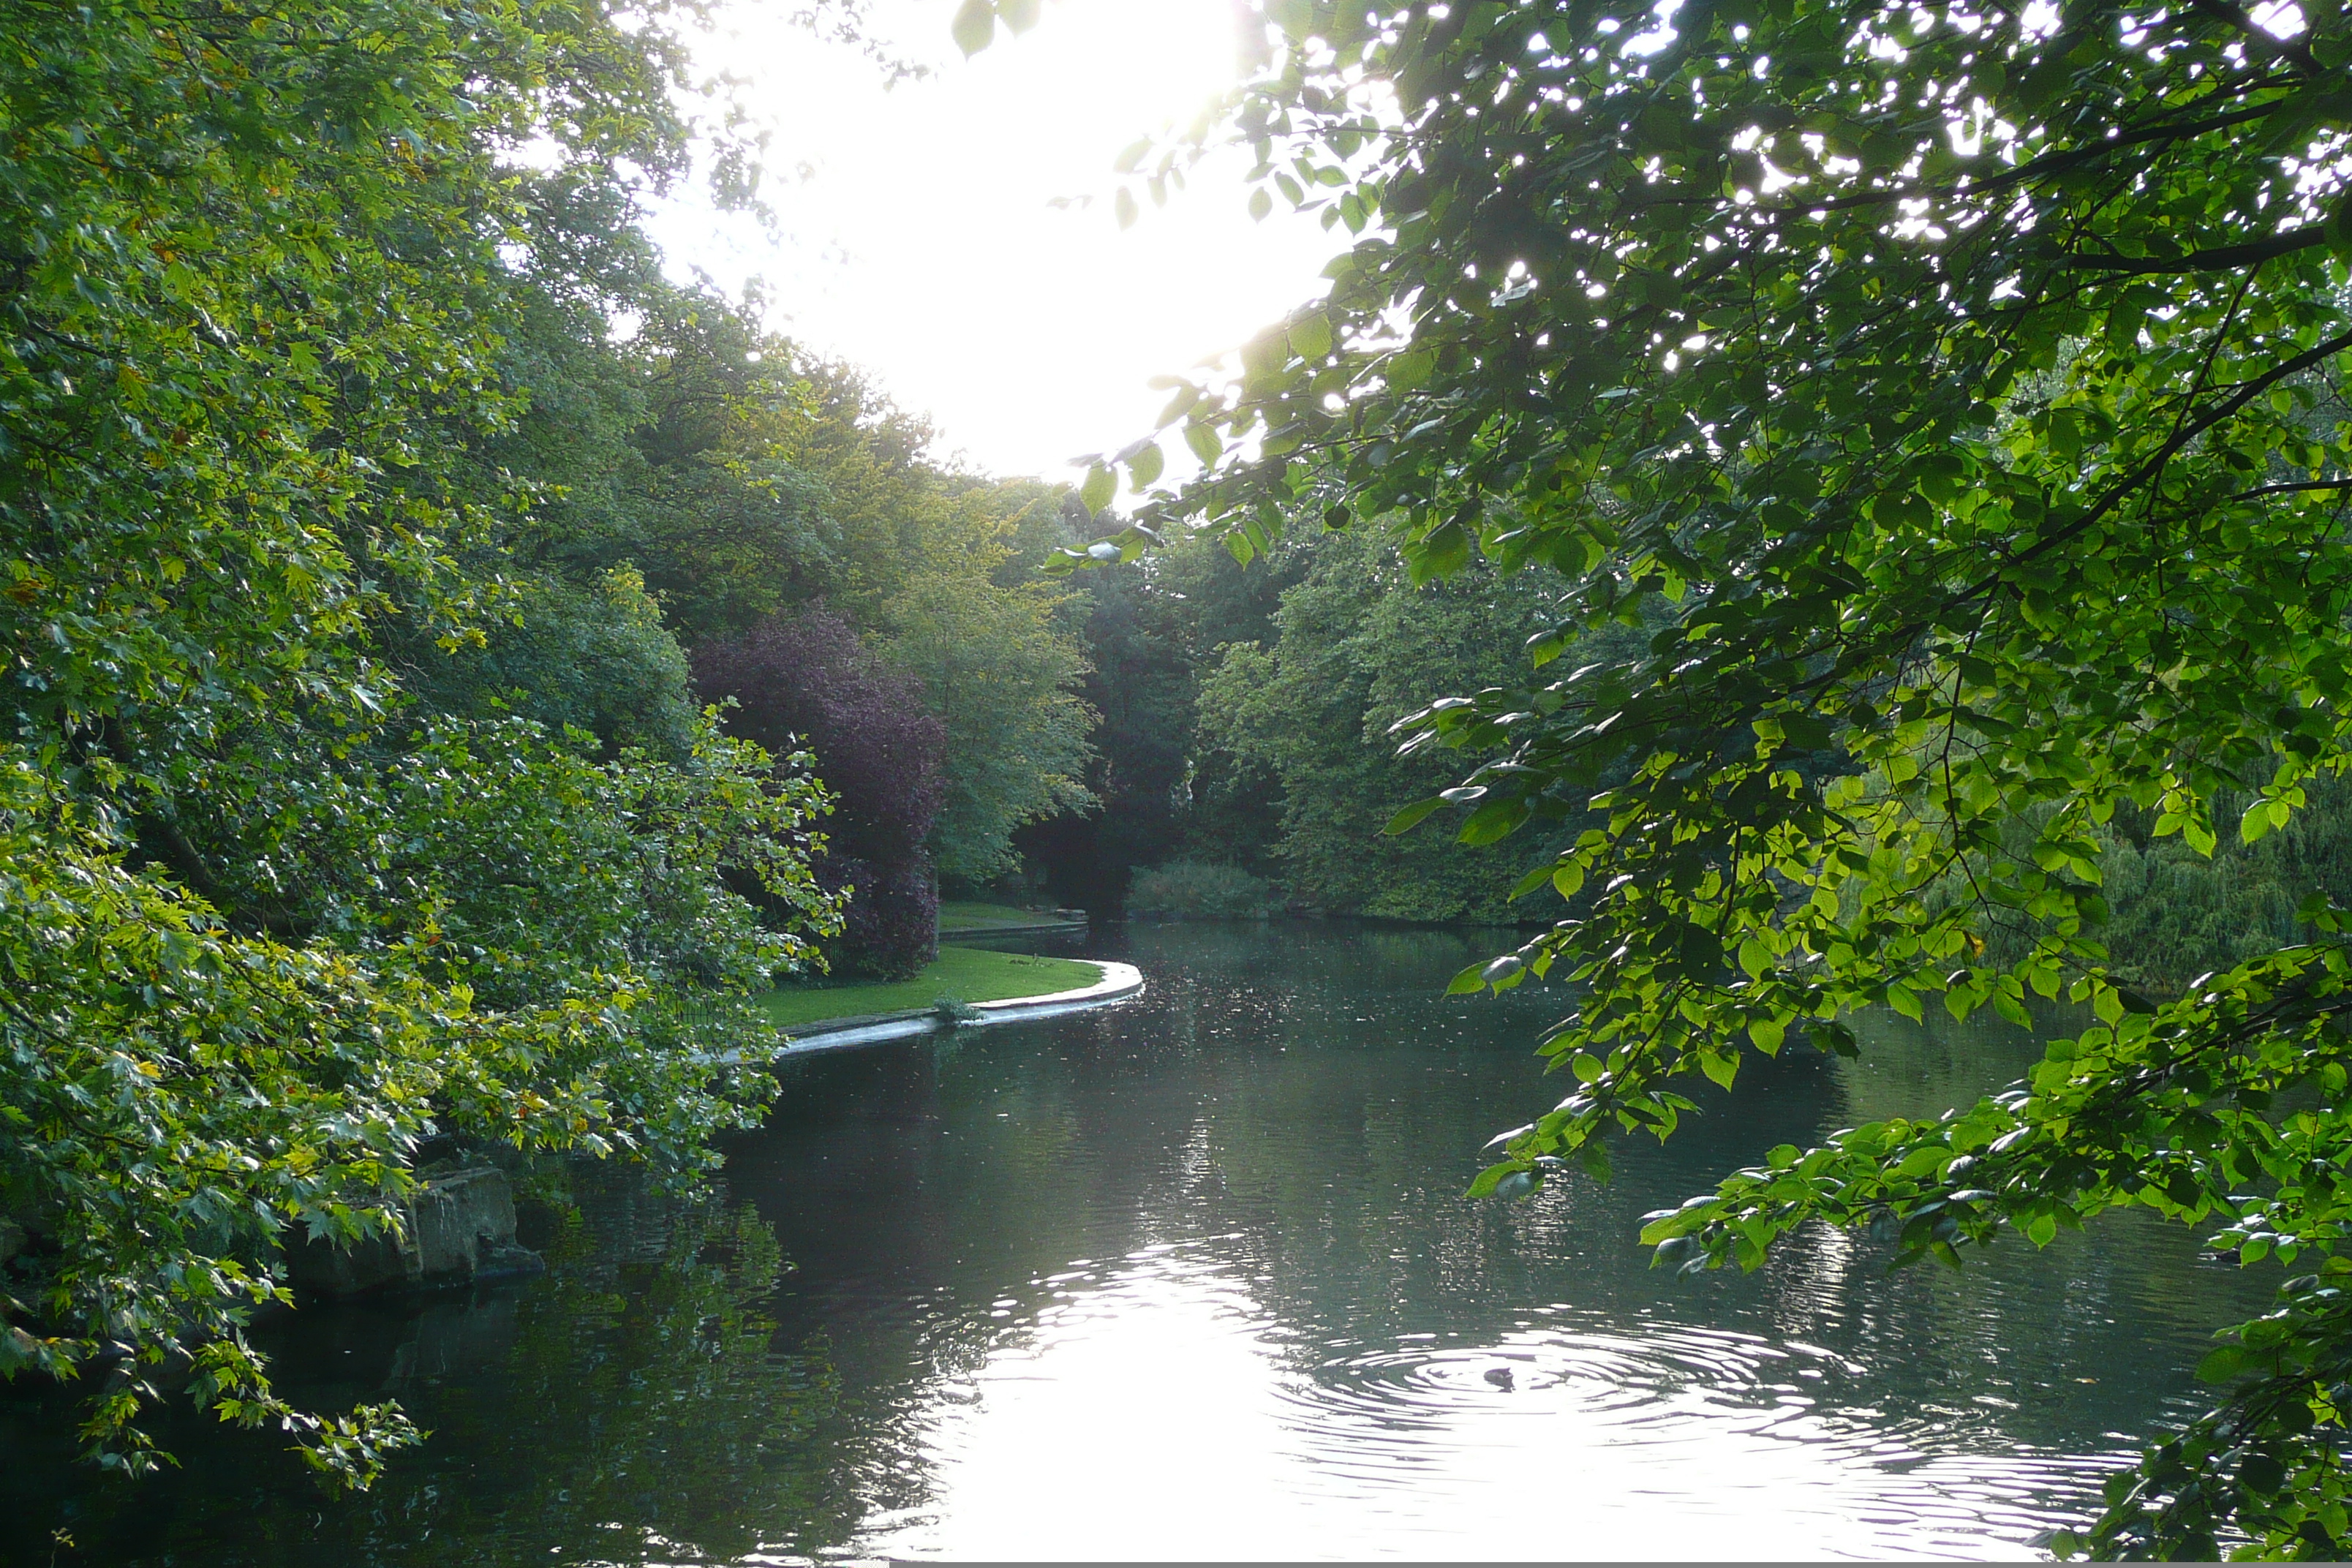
<box><xmin>0</xmin><ymin>924</ymin><xmax>2274</xmax><ymax>1564</ymax></box>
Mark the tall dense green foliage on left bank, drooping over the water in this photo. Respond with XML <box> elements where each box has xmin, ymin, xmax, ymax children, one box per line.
<box><xmin>0</xmin><ymin>0</ymin><xmax>835</xmax><ymax>1481</ymax></box>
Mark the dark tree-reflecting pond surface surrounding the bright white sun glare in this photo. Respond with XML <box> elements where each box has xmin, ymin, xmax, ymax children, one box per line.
<box><xmin>0</xmin><ymin>924</ymin><xmax>2272</xmax><ymax>1566</ymax></box>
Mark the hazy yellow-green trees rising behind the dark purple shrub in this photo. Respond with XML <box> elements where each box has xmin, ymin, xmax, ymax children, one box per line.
<box><xmin>616</xmin><ymin>343</ymin><xmax>1093</xmax><ymax>907</ymax></box>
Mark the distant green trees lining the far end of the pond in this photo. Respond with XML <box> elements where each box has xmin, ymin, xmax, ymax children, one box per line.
<box><xmin>1019</xmin><ymin>529</ymin><xmax>1640</xmax><ymax>921</ymax></box>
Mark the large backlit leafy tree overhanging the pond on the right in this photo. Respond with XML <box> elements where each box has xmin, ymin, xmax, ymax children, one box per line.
<box><xmin>962</xmin><ymin>0</ymin><xmax>2352</xmax><ymax>1556</ymax></box>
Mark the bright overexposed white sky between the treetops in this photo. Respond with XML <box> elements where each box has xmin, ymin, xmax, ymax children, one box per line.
<box><xmin>652</xmin><ymin>0</ymin><xmax>1348</xmax><ymax>478</ymax></box>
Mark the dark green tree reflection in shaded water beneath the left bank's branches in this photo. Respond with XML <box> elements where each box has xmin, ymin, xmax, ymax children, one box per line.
<box><xmin>0</xmin><ymin>1171</ymin><xmax>837</xmax><ymax>1566</ymax></box>
